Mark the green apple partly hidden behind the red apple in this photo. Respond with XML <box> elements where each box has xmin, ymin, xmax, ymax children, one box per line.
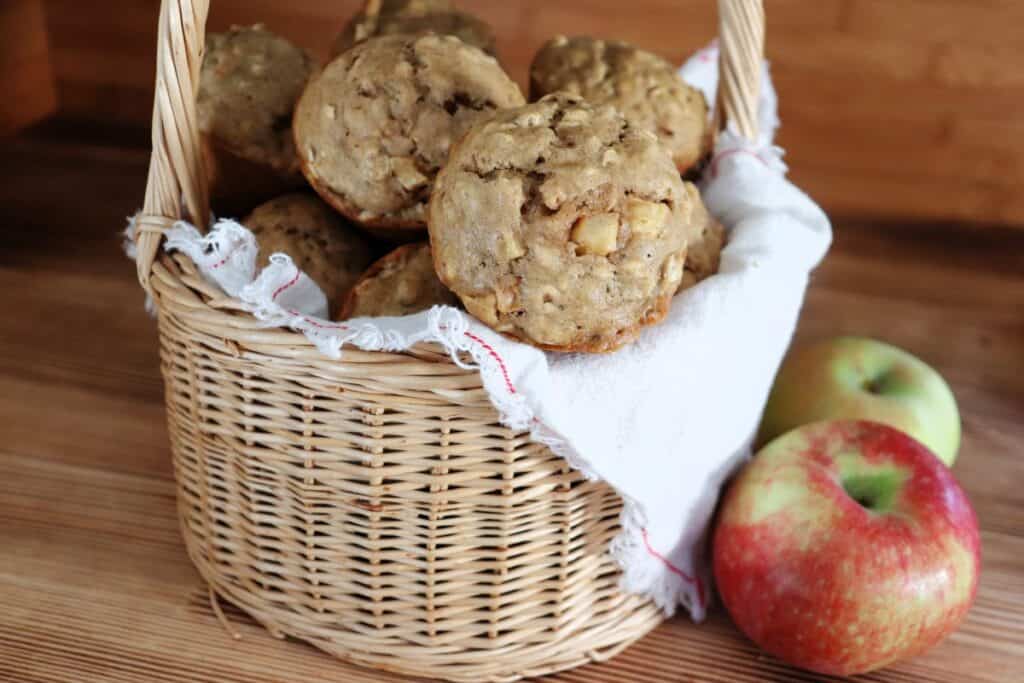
<box><xmin>758</xmin><ymin>337</ymin><xmax>961</xmax><ymax>465</ymax></box>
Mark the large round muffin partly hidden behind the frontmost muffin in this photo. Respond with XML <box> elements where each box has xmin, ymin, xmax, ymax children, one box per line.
<box><xmin>295</xmin><ymin>35</ymin><xmax>523</xmax><ymax>242</ymax></box>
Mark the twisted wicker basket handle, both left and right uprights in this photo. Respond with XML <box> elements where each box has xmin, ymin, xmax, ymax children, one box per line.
<box><xmin>135</xmin><ymin>0</ymin><xmax>765</xmax><ymax>294</ymax></box>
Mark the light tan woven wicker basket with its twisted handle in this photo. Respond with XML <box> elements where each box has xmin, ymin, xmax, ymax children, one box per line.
<box><xmin>137</xmin><ymin>0</ymin><xmax>764</xmax><ymax>683</ymax></box>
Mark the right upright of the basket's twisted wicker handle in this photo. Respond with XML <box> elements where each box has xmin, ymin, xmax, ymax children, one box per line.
<box><xmin>715</xmin><ymin>0</ymin><xmax>765</xmax><ymax>141</ymax></box>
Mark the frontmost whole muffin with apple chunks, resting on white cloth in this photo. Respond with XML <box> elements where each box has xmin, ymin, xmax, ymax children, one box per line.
<box><xmin>429</xmin><ymin>93</ymin><xmax>693</xmax><ymax>351</ymax></box>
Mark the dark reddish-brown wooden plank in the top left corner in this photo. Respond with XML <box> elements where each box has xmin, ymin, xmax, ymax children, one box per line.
<box><xmin>0</xmin><ymin>0</ymin><xmax>56</xmax><ymax>136</ymax></box>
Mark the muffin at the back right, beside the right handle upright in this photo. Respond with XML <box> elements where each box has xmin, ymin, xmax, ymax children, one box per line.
<box><xmin>529</xmin><ymin>36</ymin><xmax>711</xmax><ymax>173</ymax></box>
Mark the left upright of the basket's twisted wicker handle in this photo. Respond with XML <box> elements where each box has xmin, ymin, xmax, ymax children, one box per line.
<box><xmin>135</xmin><ymin>0</ymin><xmax>210</xmax><ymax>294</ymax></box>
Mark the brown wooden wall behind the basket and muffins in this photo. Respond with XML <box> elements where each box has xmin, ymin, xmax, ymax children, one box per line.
<box><xmin>37</xmin><ymin>0</ymin><xmax>1024</xmax><ymax>226</ymax></box>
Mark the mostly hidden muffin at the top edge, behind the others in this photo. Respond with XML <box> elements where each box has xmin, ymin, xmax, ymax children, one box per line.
<box><xmin>331</xmin><ymin>0</ymin><xmax>496</xmax><ymax>57</ymax></box>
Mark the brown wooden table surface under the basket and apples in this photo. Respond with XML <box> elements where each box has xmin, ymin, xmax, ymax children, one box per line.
<box><xmin>0</xmin><ymin>129</ymin><xmax>1024</xmax><ymax>683</ymax></box>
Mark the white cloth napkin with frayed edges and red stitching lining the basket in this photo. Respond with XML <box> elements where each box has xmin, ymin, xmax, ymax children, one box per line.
<box><xmin>142</xmin><ymin>45</ymin><xmax>831</xmax><ymax>621</ymax></box>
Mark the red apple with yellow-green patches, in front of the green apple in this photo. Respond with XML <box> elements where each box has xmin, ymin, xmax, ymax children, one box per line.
<box><xmin>713</xmin><ymin>421</ymin><xmax>980</xmax><ymax>676</ymax></box>
